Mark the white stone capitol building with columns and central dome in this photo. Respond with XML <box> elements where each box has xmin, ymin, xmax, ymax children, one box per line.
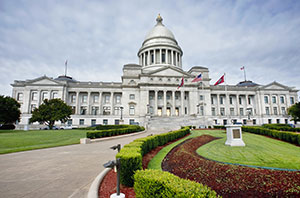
<box><xmin>12</xmin><ymin>15</ymin><xmax>298</xmax><ymax>129</ymax></box>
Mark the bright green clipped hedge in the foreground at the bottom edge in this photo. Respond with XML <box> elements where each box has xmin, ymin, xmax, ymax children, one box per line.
<box><xmin>134</xmin><ymin>170</ymin><xmax>219</xmax><ymax>198</ymax></box>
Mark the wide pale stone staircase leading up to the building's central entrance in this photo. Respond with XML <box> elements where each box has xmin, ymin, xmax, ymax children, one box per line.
<box><xmin>148</xmin><ymin>115</ymin><xmax>208</xmax><ymax>131</ymax></box>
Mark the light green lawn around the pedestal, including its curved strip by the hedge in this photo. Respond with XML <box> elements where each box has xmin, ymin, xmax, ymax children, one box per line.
<box><xmin>148</xmin><ymin>130</ymin><xmax>300</xmax><ymax>169</ymax></box>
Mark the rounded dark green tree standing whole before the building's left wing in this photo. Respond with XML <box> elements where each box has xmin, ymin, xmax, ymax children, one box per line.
<box><xmin>29</xmin><ymin>99</ymin><xmax>72</xmax><ymax>129</ymax></box>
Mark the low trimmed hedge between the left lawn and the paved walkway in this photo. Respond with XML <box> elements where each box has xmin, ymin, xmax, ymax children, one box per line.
<box><xmin>86</xmin><ymin>125</ymin><xmax>145</xmax><ymax>139</ymax></box>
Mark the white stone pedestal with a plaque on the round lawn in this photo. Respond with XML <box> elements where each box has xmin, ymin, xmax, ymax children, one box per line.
<box><xmin>225</xmin><ymin>125</ymin><xmax>245</xmax><ymax>146</ymax></box>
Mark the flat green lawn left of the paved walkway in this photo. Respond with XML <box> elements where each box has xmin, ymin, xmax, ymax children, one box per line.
<box><xmin>0</xmin><ymin>130</ymin><xmax>86</xmax><ymax>154</ymax></box>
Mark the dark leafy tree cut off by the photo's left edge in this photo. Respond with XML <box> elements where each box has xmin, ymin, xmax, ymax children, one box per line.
<box><xmin>0</xmin><ymin>96</ymin><xmax>21</xmax><ymax>124</ymax></box>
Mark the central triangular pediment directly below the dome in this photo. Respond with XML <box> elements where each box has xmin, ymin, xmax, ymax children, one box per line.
<box><xmin>148</xmin><ymin>66</ymin><xmax>191</xmax><ymax>77</ymax></box>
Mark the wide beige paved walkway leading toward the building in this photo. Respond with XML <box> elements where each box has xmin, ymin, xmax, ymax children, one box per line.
<box><xmin>0</xmin><ymin>131</ymin><xmax>166</xmax><ymax>198</ymax></box>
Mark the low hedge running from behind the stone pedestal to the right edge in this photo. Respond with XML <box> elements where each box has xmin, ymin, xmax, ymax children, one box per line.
<box><xmin>242</xmin><ymin>126</ymin><xmax>300</xmax><ymax>145</ymax></box>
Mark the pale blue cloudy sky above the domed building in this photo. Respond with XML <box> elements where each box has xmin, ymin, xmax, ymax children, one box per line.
<box><xmin>0</xmin><ymin>0</ymin><xmax>300</xmax><ymax>96</ymax></box>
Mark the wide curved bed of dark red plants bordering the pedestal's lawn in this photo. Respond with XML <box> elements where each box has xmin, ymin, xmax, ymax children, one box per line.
<box><xmin>162</xmin><ymin>135</ymin><xmax>300</xmax><ymax>197</ymax></box>
